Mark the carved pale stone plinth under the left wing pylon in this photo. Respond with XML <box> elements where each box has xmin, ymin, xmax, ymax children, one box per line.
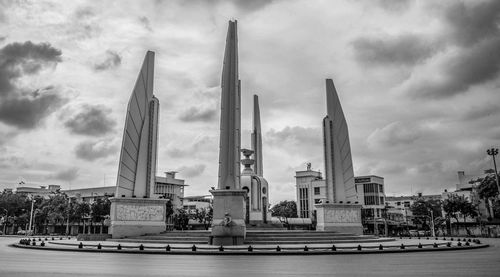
<box><xmin>109</xmin><ymin>198</ymin><xmax>167</xmax><ymax>238</ymax></box>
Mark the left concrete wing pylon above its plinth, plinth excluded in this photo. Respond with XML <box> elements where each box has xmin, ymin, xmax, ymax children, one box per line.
<box><xmin>115</xmin><ymin>51</ymin><xmax>159</xmax><ymax>198</ymax></box>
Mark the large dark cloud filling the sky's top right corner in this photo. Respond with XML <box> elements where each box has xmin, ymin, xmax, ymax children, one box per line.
<box><xmin>403</xmin><ymin>0</ymin><xmax>500</xmax><ymax>99</ymax></box>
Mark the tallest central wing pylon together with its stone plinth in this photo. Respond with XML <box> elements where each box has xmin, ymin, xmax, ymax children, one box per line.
<box><xmin>210</xmin><ymin>21</ymin><xmax>247</xmax><ymax>245</ymax></box>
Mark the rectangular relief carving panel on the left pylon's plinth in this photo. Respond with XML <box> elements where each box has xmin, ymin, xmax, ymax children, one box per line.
<box><xmin>116</xmin><ymin>205</ymin><xmax>163</xmax><ymax>221</ymax></box>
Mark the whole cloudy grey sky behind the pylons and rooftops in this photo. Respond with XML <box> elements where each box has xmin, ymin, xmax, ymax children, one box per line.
<box><xmin>0</xmin><ymin>0</ymin><xmax>500</xmax><ymax>203</ymax></box>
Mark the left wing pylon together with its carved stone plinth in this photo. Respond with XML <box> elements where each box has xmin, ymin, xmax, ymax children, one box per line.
<box><xmin>109</xmin><ymin>51</ymin><xmax>167</xmax><ymax>238</ymax></box>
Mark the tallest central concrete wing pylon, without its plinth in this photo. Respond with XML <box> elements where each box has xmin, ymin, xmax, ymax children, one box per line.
<box><xmin>218</xmin><ymin>20</ymin><xmax>241</xmax><ymax>189</ymax></box>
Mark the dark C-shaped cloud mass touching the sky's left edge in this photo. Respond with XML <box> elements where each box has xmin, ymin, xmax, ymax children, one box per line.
<box><xmin>0</xmin><ymin>41</ymin><xmax>66</xmax><ymax>129</ymax></box>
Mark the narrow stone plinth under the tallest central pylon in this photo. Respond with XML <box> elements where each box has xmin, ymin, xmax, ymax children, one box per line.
<box><xmin>210</xmin><ymin>189</ymin><xmax>246</xmax><ymax>245</ymax></box>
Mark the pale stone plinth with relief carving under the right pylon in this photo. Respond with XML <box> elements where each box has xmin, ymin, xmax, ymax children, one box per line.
<box><xmin>314</xmin><ymin>203</ymin><xmax>363</xmax><ymax>235</ymax></box>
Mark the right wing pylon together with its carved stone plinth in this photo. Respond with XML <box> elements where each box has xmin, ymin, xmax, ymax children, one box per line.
<box><xmin>315</xmin><ymin>79</ymin><xmax>363</xmax><ymax>234</ymax></box>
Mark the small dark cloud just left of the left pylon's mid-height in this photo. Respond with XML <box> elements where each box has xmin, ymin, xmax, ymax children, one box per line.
<box><xmin>64</xmin><ymin>105</ymin><xmax>116</xmax><ymax>137</ymax></box>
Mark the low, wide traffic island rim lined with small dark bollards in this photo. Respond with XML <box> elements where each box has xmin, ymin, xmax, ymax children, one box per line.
<box><xmin>12</xmin><ymin>237</ymin><xmax>489</xmax><ymax>255</ymax></box>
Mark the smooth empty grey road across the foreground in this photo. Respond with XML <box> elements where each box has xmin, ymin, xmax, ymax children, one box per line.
<box><xmin>0</xmin><ymin>237</ymin><xmax>500</xmax><ymax>277</ymax></box>
